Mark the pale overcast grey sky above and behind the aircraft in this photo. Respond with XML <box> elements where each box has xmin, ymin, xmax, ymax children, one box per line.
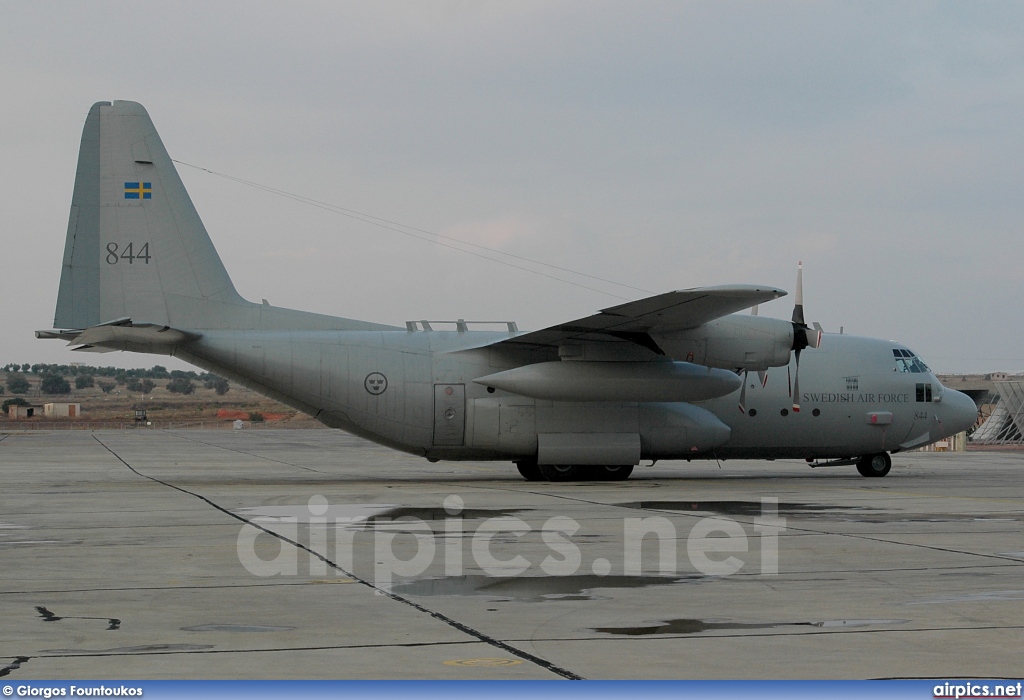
<box><xmin>0</xmin><ymin>0</ymin><xmax>1024</xmax><ymax>371</ymax></box>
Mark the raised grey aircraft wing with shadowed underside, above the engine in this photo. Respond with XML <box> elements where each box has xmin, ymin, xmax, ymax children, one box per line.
<box><xmin>493</xmin><ymin>285</ymin><xmax>786</xmax><ymax>354</ymax></box>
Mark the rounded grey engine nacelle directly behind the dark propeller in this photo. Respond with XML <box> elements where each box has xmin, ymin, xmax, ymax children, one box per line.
<box><xmin>650</xmin><ymin>314</ymin><xmax>794</xmax><ymax>371</ymax></box>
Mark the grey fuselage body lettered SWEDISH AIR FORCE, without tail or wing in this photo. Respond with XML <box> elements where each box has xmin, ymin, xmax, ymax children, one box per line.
<box><xmin>174</xmin><ymin>329</ymin><xmax>973</xmax><ymax>460</ymax></box>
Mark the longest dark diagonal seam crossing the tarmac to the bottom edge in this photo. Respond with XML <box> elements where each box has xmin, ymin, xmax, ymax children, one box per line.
<box><xmin>92</xmin><ymin>435</ymin><xmax>584</xmax><ymax>681</ymax></box>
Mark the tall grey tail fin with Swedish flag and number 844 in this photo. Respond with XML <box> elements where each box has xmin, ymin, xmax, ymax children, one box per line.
<box><xmin>53</xmin><ymin>101</ymin><xmax>251</xmax><ymax>329</ymax></box>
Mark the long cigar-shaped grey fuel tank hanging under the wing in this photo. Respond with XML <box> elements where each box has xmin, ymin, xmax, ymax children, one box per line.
<box><xmin>473</xmin><ymin>360</ymin><xmax>742</xmax><ymax>402</ymax></box>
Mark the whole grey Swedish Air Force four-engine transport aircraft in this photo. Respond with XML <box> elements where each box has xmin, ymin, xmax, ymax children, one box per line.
<box><xmin>36</xmin><ymin>101</ymin><xmax>976</xmax><ymax>481</ymax></box>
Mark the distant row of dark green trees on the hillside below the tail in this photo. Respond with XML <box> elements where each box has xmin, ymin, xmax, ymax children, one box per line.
<box><xmin>0</xmin><ymin>362</ymin><xmax>230</xmax><ymax>397</ymax></box>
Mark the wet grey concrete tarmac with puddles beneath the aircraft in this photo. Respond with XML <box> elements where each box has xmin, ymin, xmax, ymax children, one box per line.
<box><xmin>0</xmin><ymin>430</ymin><xmax>1024</xmax><ymax>681</ymax></box>
